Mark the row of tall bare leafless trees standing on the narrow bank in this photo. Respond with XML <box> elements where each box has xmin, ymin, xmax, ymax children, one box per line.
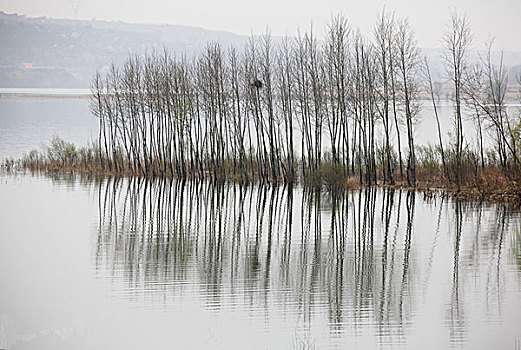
<box><xmin>91</xmin><ymin>11</ymin><xmax>519</xmax><ymax>185</ymax></box>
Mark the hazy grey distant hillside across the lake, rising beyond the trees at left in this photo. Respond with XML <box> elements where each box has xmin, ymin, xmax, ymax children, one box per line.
<box><xmin>0</xmin><ymin>11</ymin><xmax>246</xmax><ymax>88</ymax></box>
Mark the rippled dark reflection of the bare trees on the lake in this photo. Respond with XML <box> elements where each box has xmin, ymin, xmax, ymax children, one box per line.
<box><xmin>94</xmin><ymin>179</ymin><xmax>520</xmax><ymax>344</ymax></box>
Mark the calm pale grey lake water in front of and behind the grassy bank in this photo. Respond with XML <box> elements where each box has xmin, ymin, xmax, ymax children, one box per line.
<box><xmin>0</xmin><ymin>97</ymin><xmax>521</xmax><ymax>350</ymax></box>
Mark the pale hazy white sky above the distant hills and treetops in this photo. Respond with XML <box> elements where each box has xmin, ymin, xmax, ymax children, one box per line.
<box><xmin>0</xmin><ymin>0</ymin><xmax>521</xmax><ymax>51</ymax></box>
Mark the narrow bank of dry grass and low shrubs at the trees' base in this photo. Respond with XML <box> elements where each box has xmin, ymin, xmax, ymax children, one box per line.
<box><xmin>2</xmin><ymin>137</ymin><xmax>521</xmax><ymax>205</ymax></box>
